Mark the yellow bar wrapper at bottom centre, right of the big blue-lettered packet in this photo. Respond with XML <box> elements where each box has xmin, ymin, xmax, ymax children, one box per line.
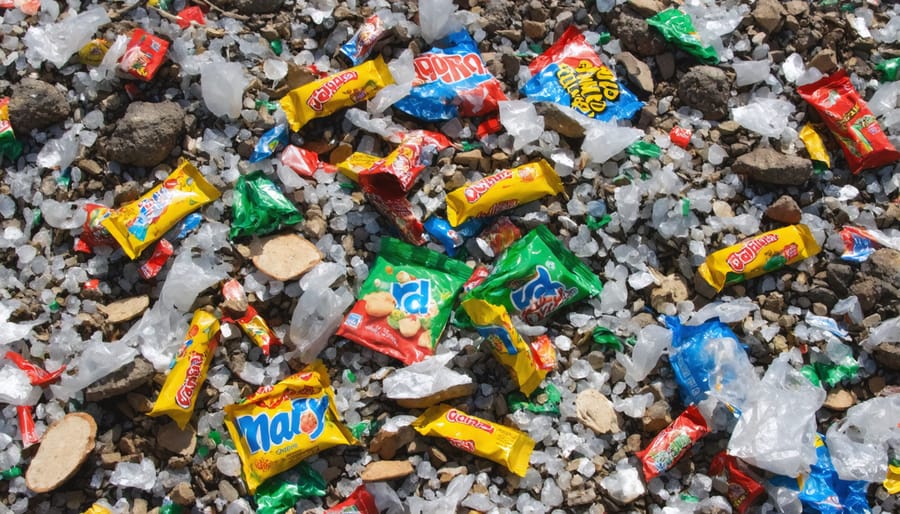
<box><xmin>411</xmin><ymin>404</ymin><xmax>534</xmax><ymax>477</ymax></box>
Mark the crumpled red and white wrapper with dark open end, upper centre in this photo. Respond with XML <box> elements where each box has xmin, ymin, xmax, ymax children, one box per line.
<box><xmin>359</xmin><ymin>130</ymin><xmax>450</xmax><ymax>198</ymax></box>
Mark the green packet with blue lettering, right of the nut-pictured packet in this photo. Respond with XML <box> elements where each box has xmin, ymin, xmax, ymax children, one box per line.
<box><xmin>457</xmin><ymin>225</ymin><xmax>602</xmax><ymax>324</ymax></box>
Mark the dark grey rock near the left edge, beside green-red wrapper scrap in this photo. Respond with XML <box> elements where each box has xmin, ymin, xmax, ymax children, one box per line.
<box><xmin>8</xmin><ymin>78</ymin><xmax>72</xmax><ymax>133</ymax></box>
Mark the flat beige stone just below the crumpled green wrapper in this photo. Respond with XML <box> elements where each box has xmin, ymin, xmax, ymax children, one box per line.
<box><xmin>250</xmin><ymin>234</ymin><xmax>322</xmax><ymax>282</ymax></box>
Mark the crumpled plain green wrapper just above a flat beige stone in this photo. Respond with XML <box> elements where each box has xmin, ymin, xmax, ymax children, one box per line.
<box><xmin>228</xmin><ymin>171</ymin><xmax>303</xmax><ymax>239</ymax></box>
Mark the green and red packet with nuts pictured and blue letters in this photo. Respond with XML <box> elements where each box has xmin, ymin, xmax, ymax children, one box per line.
<box><xmin>337</xmin><ymin>237</ymin><xmax>472</xmax><ymax>364</ymax></box>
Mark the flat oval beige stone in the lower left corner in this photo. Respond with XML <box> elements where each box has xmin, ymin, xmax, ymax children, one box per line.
<box><xmin>25</xmin><ymin>412</ymin><xmax>97</xmax><ymax>493</ymax></box>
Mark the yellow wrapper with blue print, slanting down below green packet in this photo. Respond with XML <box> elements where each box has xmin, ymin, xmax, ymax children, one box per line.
<box><xmin>462</xmin><ymin>298</ymin><xmax>547</xmax><ymax>396</ymax></box>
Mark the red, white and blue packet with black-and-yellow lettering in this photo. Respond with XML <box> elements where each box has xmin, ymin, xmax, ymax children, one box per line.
<box><xmin>522</xmin><ymin>25</ymin><xmax>644</xmax><ymax>121</ymax></box>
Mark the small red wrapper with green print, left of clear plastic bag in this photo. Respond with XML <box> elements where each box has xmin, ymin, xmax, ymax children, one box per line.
<box><xmin>635</xmin><ymin>405</ymin><xmax>709</xmax><ymax>482</ymax></box>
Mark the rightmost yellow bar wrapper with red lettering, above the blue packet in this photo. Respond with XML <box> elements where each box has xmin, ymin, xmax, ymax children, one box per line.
<box><xmin>697</xmin><ymin>225</ymin><xmax>821</xmax><ymax>292</ymax></box>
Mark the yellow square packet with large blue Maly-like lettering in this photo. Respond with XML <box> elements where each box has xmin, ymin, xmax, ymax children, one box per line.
<box><xmin>225</xmin><ymin>361</ymin><xmax>358</xmax><ymax>494</ymax></box>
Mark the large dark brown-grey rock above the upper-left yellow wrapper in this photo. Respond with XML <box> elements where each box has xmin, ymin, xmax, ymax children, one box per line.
<box><xmin>106</xmin><ymin>102</ymin><xmax>184</xmax><ymax>168</ymax></box>
